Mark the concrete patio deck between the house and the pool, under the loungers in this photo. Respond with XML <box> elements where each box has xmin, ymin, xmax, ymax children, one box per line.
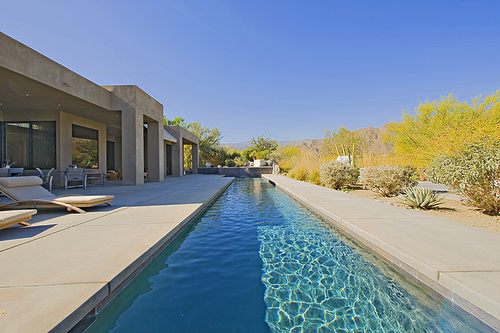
<box><xmin>0</xmin><ymin>175</ymin><xmax>234</xmax><ymax>332</ymax></box>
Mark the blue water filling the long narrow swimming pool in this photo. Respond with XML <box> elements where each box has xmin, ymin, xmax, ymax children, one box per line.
<box><xmin>85</xmin><ymin>178</ymin><xmax>492</xmax><ymax>333</ymax></box>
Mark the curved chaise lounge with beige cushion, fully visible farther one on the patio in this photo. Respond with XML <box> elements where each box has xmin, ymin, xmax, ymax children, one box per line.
<box><xmin>0</xmin><ymin>176</ymin><xmax>114</xmax><ymax>213</ymax></box>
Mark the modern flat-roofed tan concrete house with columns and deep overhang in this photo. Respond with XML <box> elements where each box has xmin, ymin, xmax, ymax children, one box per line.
<box><xmin>0</xmin><ymin>32</ymin><xmax>199</xmax><ymax>185</ymax></box>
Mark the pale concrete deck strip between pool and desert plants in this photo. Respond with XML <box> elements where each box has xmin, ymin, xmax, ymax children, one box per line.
<box><xmin>262</xmin><ymin>175</ymin><xmax>500</xmax><ymax>331</ymax></box>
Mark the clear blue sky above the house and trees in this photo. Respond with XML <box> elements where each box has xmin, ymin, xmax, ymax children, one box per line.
<box><xmin>0</xmin><ymin>0</ymin><xmax>500</xmax><ymax>142</ymax></box>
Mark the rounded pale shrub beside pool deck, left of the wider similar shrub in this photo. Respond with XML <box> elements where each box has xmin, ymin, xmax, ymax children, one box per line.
<box><xmin>320</xmin><ymin>161</ymin><xmax>359</xmax><ymax>190</ymax></box>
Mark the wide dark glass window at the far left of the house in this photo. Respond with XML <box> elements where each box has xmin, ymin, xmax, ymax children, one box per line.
<box><xmin>1</xmin><ymin>121</ymin><xmax>56</xmax><ymax>170</ymax></box>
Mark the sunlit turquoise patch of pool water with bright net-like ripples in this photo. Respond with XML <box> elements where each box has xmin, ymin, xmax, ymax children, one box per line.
<box><xmin>258</xmin><ymin>219</ymin><xmax>458</xmax><ymax>333</ymax></box>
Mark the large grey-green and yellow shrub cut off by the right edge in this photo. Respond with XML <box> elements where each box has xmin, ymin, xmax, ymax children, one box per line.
<box><xmin>428</xmin><ymin>139</ymin><xmax>500</xmax><ymax>214</ymax></box>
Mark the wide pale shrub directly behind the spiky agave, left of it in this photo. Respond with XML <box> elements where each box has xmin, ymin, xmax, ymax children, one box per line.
<box><xmin>360</xmin><ymin>165</ymin><xmax>413</xmax><ymax>197</ymax></box>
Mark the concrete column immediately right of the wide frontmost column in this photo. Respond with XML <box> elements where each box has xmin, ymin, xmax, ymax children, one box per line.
<box><xmin>147</xmin><ymin>121</ymin><xmax>164</xmax><ymax>182</ymax></box>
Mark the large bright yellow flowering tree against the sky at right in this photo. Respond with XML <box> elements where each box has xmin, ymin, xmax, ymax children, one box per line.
<box><xmin>385</xmin><ymin>90</ymin><xmax>500</xmax><ymax>168</ymax></box>
